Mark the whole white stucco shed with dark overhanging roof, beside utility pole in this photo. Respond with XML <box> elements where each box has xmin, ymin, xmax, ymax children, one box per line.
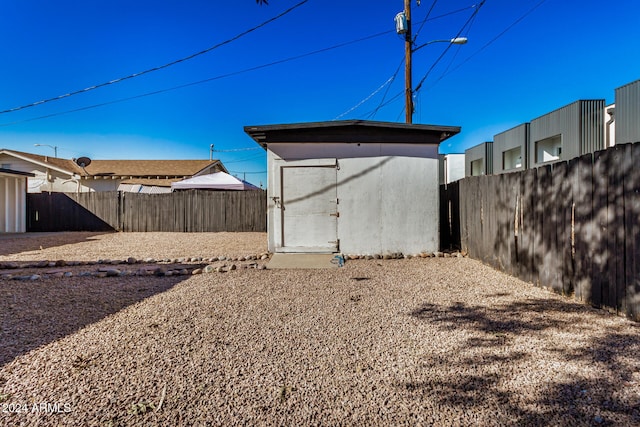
<box><xmin>244</xmin><ymin>120</ymin><xmax>460</xmax><ymax>255</ymax></box>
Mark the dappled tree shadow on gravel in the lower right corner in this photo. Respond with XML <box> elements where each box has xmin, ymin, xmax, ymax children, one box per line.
<box><xmin>404</xmin><ymin>299</ymin><xmax>640</xmax><ymax>426</ymax></box>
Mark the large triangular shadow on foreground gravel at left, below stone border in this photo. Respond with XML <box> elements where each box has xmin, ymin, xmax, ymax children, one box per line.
<box><xmin>0</xmin><ymin>276</ymin><xmax>190</xmax><ymax>367</ymax></box>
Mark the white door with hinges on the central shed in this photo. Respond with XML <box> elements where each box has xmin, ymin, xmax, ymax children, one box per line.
<box><xmin>280</xmin><ymin>165</ymin><xmax>338</xmax><ymax>252</ymax></box>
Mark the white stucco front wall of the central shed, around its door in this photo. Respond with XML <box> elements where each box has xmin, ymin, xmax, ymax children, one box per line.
<box><xmin>267</xmin><ymin>144</ymin><xmax>439</xmax><ymax>255</ymax></box>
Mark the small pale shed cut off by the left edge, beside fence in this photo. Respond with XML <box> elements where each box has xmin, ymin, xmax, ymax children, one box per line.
<box><xmin>0</xmin><ymin>168</ymin><xmax>34</xmax><ymax>233</ymax></box>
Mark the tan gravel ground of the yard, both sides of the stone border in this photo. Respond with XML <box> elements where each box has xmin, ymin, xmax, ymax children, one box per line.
<box><xmin>0</xmin><ymin>233</ymin><xmax>640</xmax><ymax>426</ymax></box>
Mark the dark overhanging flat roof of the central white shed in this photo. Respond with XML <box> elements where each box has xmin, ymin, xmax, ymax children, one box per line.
<box><xmin>244</xmin><ymin>120</ymin><xmax>461</xmax><ymax>149</ymax></box>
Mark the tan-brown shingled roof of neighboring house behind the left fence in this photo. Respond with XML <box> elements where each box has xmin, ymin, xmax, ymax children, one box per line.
<box><xmin>0</xmin><ymin>149</ymin><xmax>226</xmax><ymax>179</ymax></box>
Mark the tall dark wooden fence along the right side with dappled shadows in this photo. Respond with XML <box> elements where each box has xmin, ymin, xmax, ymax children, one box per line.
<box><xmin>441</xmin><ymin>143</ymin><xmax>640</xmax><ymax>320</ymax></box>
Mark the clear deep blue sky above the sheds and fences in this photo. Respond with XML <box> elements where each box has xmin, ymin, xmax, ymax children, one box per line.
<box><xmin>0</xmin><ymin>0</ymin><xmax>640</xmax><ymax>184</ymax></box>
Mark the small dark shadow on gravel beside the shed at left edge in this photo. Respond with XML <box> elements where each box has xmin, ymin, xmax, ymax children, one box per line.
<box><xmin>0</xmin><ymin>231</ymin><xmax>114</xmax><ymax>255</ymax></box>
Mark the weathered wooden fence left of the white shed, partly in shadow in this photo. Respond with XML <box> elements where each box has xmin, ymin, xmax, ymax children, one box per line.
<box><xmin>27</xmin><ymin>190</ymin><xmax>267</xmax><ymax>232</ymax></box>
